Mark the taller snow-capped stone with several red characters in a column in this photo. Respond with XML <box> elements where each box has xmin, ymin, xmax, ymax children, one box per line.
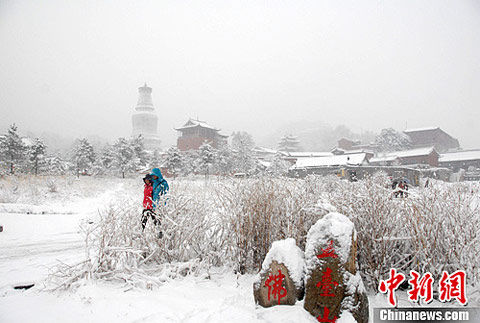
<box><xmin>304</xmin><ymin>213</ymin><xmax>368</xmax><ymax>323</ymax></box>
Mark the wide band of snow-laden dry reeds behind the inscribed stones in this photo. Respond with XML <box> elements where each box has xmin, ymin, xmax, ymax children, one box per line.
<box><xmin>50</xmin><ymin>175</ymin><xmax>480</xmax><ymax>289</ymax></box>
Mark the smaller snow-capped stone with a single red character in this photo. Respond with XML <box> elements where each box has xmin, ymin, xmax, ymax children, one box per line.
<box><xmin>253</xmin><ymin>238</ymin><xmax>305</xmax><ymax>307</ymax></box>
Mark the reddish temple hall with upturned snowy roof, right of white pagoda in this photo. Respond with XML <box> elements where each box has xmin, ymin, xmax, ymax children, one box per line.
<box><xmin>175</xmin><ymin>119</ymin><xmax>228</xmax><ymax>151</ymax></box>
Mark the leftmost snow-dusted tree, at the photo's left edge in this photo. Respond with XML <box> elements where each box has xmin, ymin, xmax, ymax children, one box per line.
<box><xmin>0</xmin><ymin>124</ymin><xmax>26</xmax><ymax>174</ymax></box>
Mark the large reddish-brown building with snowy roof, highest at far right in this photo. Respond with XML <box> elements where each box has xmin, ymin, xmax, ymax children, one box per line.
<box><xmin>404</xmin><ymin>127</ymin><xmax>460</xmax><ymax>152</ymax></box>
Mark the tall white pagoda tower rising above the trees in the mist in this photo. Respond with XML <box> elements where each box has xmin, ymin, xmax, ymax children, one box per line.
<box><xmin>132</xmin><ymin>83</ymin><xmax>161</xmax><ymax>150</ymax></box>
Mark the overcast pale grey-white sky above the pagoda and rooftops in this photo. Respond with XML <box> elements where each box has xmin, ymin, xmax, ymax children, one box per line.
<box><xmin>0</xmin><ymin>0</ymin><xmax>480</xmax><ymax>148</ymax></box>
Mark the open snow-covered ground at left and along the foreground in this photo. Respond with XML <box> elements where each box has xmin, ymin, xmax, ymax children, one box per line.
<box><xmin>0</xmin><ymin>177</ymin><xmax>478</xmax><ymax>323</ymax></box>
